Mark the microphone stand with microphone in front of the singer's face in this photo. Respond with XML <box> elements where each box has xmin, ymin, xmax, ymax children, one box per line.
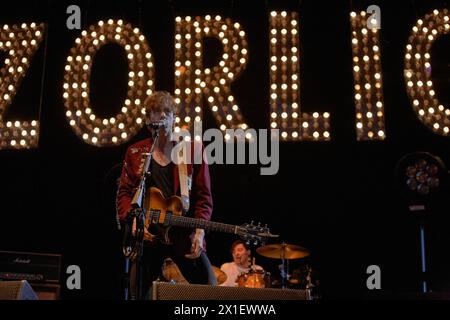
<box><xmin>124</xmin><ymin>130</ymin><xmax>159</xmax><ymax>300</ymax></box>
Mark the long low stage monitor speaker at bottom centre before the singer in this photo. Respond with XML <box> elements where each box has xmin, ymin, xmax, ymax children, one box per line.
<box><xmin>152</xmin><ymin>281</ymin><xmax>311</xmax><ymax>300</ymax></box>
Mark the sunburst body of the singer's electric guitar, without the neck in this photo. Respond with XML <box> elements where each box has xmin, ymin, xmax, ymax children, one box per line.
<box><xmin>144</xmin><ymin>187</ymin><xmax>183</xmax><ymax>244</ymax></box>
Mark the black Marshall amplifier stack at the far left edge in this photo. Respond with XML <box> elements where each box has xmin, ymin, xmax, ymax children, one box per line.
<box><xmin>0</xmin><ymin>251</ymin><xmax>61</xmax><ymax>300</ymax></box>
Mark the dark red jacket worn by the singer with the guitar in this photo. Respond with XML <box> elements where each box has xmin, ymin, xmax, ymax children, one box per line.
<box><xmin>117</xmin><ymin>138</ymin><xmax>213</xmax><ymax>252</ymax></box>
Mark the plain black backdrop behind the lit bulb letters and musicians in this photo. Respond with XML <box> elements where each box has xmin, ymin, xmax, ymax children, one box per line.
<box><xmin>0</xmin><ymin>0</ymin><xmax>450</xmax><ymax>299</ymax></box>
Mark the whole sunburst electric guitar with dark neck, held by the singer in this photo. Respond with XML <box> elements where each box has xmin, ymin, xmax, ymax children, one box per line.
<box><xmin>139</xmin><ymin>187</ymin><xmax>278</xmax><ymax>245</ymax></box>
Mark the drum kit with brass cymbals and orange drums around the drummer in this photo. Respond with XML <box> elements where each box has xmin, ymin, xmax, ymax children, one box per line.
<box><xmin>162</xmin><ymin>243</ymin><xmax>314</xmax><ymax>289</ymax></box>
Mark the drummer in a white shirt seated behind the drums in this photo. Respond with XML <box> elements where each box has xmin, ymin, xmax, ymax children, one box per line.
<box><xmin>220</xmin><ymin>240</ymin><xmax>264</xmax><ymax>287</ymax></box>
